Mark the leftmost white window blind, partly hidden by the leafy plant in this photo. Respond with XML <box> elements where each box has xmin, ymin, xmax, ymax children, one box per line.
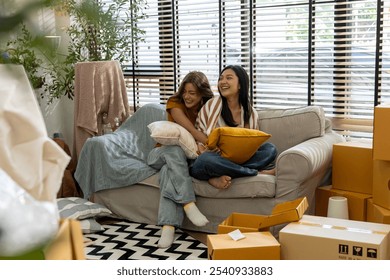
<box><xmin>125</xmin><ymin>0</ymin><xmax>175</xmax><ymax>110</ymax></box>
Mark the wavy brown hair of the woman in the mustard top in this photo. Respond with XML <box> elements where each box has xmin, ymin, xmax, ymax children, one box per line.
<box><xmin>172</xmin><ymin>71</ymin><xmax>214</xmax><ymax>111</ymax></box>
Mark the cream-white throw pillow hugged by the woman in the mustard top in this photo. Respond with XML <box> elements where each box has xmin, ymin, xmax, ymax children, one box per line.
<box><xmin>148</xmin><ymin>121</ymin><xmax>198</xmax><ymax>159</ymax></box>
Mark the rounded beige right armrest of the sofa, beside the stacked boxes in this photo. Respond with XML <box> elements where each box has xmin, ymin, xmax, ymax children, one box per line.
<box><xmin>276</xmin><ymin>132</ymin><xmax>345</xmax><ymax>197</ymax></box>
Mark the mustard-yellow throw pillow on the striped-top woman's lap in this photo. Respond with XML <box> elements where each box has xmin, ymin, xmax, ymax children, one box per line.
<box><xmin>207</xmin><ymin>127</ymin><xmax>271</xmax><ymax>164</ymax></box>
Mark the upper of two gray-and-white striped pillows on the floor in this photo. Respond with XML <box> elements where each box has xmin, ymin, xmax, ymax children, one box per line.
<box><xmin>57</xmin><ymin>197</ymin><xmax>115</xmax><ymax>220</ymax></box>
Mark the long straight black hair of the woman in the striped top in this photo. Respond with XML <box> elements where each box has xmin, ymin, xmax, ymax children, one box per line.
<box><xmin>218</xmin><ymin>65</ymin><xmax>252</xmax><ymax>126</ymax></box>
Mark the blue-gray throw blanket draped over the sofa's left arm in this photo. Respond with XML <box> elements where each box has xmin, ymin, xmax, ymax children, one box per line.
<box><xmin>75</xmin><ymin>101</ymin><xmax>166</xmax><ymax>198</ymax></box>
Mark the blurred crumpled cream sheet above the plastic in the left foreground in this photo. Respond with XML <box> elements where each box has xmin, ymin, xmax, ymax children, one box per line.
<box><xmin>0</xmin><ymin>64</ymin><xmax>70</xmax><ymax>202</ymax></box>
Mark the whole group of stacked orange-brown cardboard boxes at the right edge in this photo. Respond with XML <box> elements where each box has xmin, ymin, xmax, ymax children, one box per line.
<box><xmin>315</xmin><ymin>105</ymin><xmax>390</xmax><ymax>223</ymax></box>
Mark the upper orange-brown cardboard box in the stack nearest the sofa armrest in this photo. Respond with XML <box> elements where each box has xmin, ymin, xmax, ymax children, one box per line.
<box><xmin>332</xmin><ymin>141</ymin><xmax>372</xmax><ymax>194</ymax></box>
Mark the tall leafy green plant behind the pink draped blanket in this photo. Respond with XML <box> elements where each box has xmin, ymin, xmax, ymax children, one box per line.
<box><xmin>45</xmin><ymin>0</ymin><xmax>146</xmax><ymax>103</ymax></box>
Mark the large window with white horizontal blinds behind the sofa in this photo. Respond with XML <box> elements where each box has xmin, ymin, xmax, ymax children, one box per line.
<box><xmin>126</xmin><ymin>0</ymin><xmax>390</xmax><ymax>138</ymax></box>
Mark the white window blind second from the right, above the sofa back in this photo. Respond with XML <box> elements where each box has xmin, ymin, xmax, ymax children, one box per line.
<box><xmin>253</xmin><ymin>0</ymin><xmax>309</xmax><ymax>109</ymax></box>
